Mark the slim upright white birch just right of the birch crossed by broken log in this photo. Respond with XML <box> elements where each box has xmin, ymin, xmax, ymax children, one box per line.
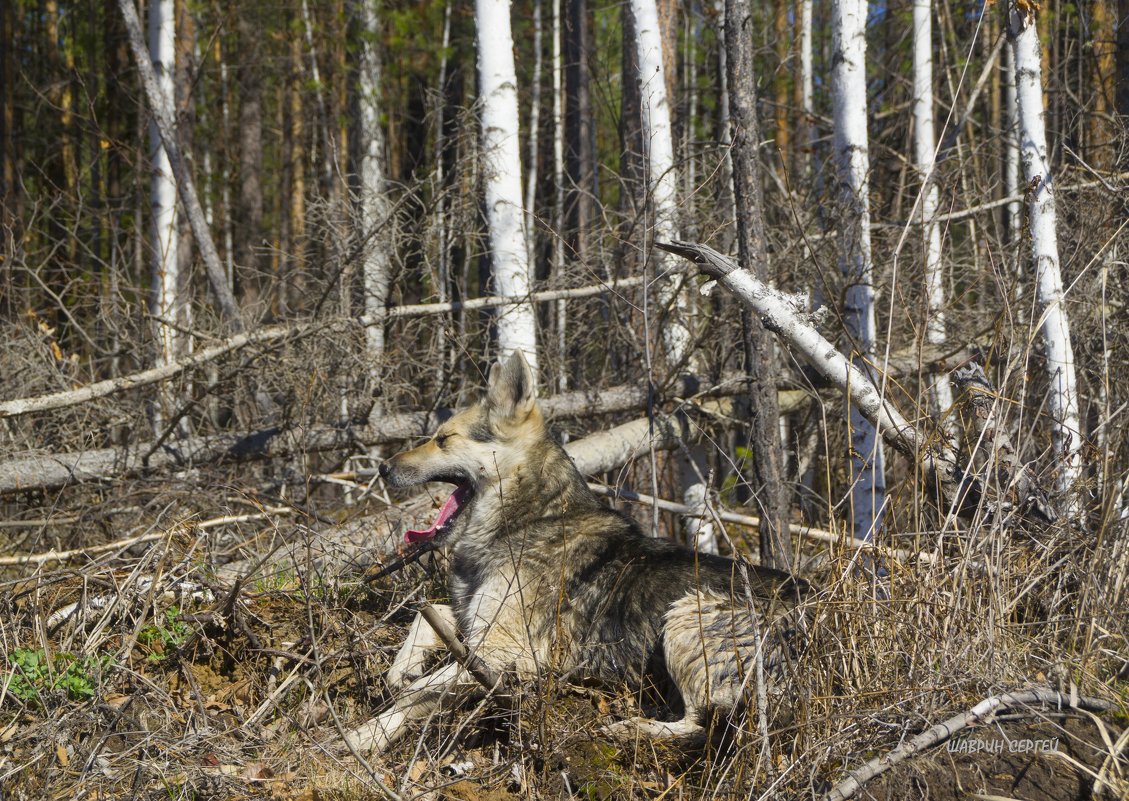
<box><xmin>913</xmin><ymin>0</ymin><xmax>953</xmax><ymax>419</ymax></box>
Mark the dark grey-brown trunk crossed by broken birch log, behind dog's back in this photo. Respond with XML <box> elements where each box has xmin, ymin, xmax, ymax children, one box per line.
<box><xmin>725</xmin><ymin>0</ymin><xmax>791</xmax><ymax>569</ymax></box>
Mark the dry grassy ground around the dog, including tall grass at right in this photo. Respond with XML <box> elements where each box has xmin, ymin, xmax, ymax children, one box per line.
<box><xmin>0</xmin><ymin>456</ymin><xmax>1129</xmax><ymax>801</ymax></box>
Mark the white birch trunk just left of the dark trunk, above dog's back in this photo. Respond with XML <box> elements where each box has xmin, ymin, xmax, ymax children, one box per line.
<box><xmin>631</xmin><ymin>0</ymin><xmax>717</xmax><ymax>554</ymax></box>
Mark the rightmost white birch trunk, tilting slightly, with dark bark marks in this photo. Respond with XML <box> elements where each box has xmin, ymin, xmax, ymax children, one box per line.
<box><xmin>1007</xmin><ymin>0</ymin><xmax>1082</xmax><ymax>492</ymax></box>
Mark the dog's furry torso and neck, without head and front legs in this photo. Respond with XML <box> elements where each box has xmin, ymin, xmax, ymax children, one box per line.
<box><xmin>452</xmin><ymin>427</ymin><xmax>807</xmax><ymax>716</ymax></box>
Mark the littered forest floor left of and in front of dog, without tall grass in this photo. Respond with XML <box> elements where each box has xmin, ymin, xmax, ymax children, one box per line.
<box><xmin>0</xmin><ymin>488</ymin><xmax>1129</xmax><ymax>801</ymax></box>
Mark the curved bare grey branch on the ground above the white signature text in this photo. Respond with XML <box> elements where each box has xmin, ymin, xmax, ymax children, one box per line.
<box><xmin>826</xmin><ymin>687</ymin><xmax>1113</xmax><ymax>801</ymax></box>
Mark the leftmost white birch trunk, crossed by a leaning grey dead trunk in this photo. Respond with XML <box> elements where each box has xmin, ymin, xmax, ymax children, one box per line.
<box><xmin>149</xmin><ymin>0</ymin><xmax>183</xmax><ymax>377</ymax></box>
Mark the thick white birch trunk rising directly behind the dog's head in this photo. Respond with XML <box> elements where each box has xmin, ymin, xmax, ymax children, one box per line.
<box><xmin>474</xmin><ymin>0</ymin><xmax>537</xmax><ymax>375</ymax></box>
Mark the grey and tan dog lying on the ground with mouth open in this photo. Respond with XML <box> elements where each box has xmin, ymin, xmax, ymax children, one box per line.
<box><xmin>352</xmin><ymin>352</ymin><xmax>807</xmax><ymax>749</ymax></box>
